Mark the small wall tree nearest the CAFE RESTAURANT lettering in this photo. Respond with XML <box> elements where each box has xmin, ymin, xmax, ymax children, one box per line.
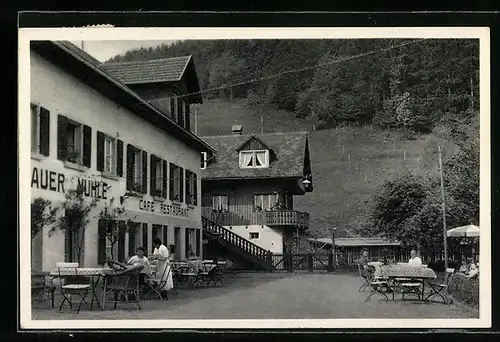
<box><xmin>99</xmin><ymin>197</ymin><xmax>136</xmax><ymax>259</ymax></box>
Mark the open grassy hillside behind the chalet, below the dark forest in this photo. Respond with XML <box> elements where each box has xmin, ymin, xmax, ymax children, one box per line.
<box><xmin>192</xmin><ymin>100</ymin><xmax>454</xmax><ymax>237</ymax></box>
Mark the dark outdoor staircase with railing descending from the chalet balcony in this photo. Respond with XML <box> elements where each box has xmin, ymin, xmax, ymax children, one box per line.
<box><xmin>201</xmin><ymin>216</ymin><xmax>274</xmax><ymax>271</ymax></box>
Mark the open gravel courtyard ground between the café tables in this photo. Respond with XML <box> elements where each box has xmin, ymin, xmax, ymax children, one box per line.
<box><xmin>32</xmin><ymin>273</ymin><xmax>479</xmax><ymax>320</ymax></box>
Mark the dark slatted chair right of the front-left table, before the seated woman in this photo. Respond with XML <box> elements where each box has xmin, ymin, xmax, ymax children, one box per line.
<box><xmin>101</xmin><ymin>265</ymin><xmax>144</xmax><ymax>310</ymax></box>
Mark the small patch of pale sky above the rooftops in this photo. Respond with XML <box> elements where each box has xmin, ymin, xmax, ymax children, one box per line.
<box><xmin>71</xmin><ymin>40</ymin><xmax>175</xmax><ymax>62</ymax></box>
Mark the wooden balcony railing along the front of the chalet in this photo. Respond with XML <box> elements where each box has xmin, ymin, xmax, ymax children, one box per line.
<box><xmin>202</xmin><ymin>207</ymin><xmax>309</xmax><ymax>229</ymax></box>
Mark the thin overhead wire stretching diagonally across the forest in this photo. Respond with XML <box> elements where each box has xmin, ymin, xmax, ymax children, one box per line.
<box><xmin>174</xmin><ymin>38</ymin><xmax>426</xmax><ymax>98</ymax></box>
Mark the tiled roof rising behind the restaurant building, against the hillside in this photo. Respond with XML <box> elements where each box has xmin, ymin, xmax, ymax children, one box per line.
<box><xmin>101</xmin><ymin>56</ymin><xmax>191</xmax><ymax>85</ymax></box>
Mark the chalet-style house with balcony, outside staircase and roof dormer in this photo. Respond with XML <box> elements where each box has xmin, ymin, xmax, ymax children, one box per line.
<box><xmin>201</xmin><ymin>127</ymin><xmax>313</xmax><ymax>267</ymax></box>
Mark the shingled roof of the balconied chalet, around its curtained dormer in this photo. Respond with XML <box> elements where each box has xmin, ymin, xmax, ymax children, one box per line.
<box><xmin>201</xmin><ymin>132</ymin><xmax>308</xmax><ymax>179</ymax></box>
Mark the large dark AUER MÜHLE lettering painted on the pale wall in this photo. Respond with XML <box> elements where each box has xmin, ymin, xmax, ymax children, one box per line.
<box><xmin>31</xmin><ymin>167</ymin><xmax>109</xmax><ymax>199</ymax></box>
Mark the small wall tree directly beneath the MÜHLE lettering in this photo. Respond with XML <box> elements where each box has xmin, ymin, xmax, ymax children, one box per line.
<box><xmin>50</xmin><ymin>186</ymin><xmax>97</xmax><ymax>263</ymax></box>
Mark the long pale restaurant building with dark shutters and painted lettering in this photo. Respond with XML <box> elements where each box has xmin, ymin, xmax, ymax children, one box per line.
<box><xmin>31</xmin><ymin>41</ymin><xmax>215</xmax><ymax>270</ymax></box>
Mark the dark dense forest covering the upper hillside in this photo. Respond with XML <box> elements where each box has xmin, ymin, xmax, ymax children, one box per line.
<box><xmin>110</xmin><ymin>39</ymin><xmax>479</xmax><ymax>136</ymax></box>
